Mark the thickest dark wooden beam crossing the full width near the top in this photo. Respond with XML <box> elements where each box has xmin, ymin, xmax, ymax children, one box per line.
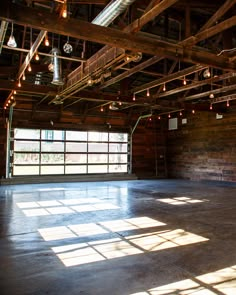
<box><xmin>0</xmin><ymin>0</ymin><xmax>236</xmax><ymax>70</ymax></box>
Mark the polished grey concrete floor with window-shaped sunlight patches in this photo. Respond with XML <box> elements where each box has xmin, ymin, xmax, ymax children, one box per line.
<box><xmin>0</xmin><ymin>180</ymin><xmax>236</xmax><ymax>295</ymax></box>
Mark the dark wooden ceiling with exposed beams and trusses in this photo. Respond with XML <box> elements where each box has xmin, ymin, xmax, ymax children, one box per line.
<box><xmin>0</xmin><ymin>0</ymin><xmax>236</xmax><ymax>126</ymax></box>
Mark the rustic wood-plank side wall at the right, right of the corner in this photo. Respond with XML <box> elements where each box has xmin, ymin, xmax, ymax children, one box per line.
<box><xmin>167</xmin><ymin>108</ymin><xmax>236</xmax><ymax>181</ymax></box>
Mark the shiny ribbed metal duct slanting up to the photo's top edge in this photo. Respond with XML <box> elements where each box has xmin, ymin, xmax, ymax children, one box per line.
<box><xmin>92</xmin><ymin>0</ymin><xmax>135</xmax><ymax>27</ymax></box>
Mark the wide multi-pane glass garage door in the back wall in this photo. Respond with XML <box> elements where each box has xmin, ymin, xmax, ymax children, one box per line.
<box><xmin>12</xmin><ymin>128</ymin><xmax>128</xmax><ymax>175</ymax></box>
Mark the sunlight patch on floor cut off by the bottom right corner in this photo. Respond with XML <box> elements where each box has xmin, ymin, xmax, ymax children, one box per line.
<box><xmin>130</xmin><ymin>266</ymin><xmax>236</xmax><ymax>295</ymax></box>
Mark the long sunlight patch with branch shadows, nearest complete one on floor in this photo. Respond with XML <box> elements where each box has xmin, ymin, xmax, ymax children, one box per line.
<box><xmin>52</xmin><ymin>229</ymin><xmax>207</xmax><ymax>268</ymax></box>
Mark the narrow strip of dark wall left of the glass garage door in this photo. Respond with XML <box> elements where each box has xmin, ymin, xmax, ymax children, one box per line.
<box><xmin>0</xmin><ymin>119</ymin><xmax>7</xmax><ymax>178</ymax></box>
